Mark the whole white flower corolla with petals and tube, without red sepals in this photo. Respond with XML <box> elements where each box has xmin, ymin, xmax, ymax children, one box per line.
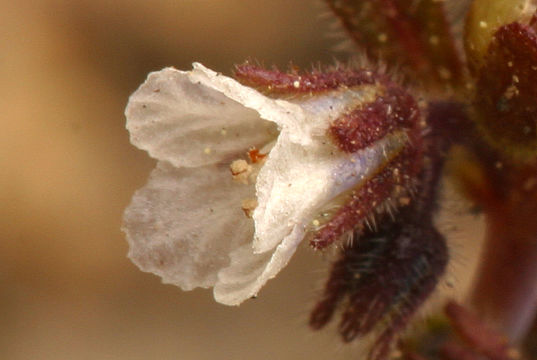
<box><xmin>123</xmin><ymin>64</ymin><xmax>406</xmax><ymax>305</ymax></box>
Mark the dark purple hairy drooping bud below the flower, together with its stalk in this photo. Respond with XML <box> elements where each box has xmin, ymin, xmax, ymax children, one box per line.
<box><xmin>310</xmin><ymin>97</ymin><xmax>454</xmax><ymax>360</ymax></box>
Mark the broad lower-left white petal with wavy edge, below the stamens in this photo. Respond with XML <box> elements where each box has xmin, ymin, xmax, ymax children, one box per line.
<box><xmin>123</xmin><ymin>162</ymin><xmax>253</xmax><ymax>290</ymax></box>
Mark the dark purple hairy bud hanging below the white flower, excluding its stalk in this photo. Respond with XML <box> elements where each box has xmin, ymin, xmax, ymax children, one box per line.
<box><xmin>310</xmin><ymin>211</ymin><xmax>448</xmax><ymax>360</ymax></box>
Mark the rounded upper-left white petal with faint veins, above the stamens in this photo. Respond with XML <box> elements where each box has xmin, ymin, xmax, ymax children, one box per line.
<box><xmin>125</xmin><ymin>68</ymin><xmax>275</xmax><ymax>167</ymax></box>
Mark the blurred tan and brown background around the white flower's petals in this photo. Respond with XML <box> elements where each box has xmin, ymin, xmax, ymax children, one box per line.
<box><xmin>0</xmin><ymin>0</ymin><xmax>368</xmax><ymax>360</ymax></box>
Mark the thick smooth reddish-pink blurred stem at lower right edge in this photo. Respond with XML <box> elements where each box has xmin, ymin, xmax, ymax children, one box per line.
<box><xmin>471</xmin><ymin>205</ymin><xmax>537</xmax><ymax>343</ymax></box>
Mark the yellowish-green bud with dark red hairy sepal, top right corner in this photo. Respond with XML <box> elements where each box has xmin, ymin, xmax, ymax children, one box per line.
<box><xmin>465</xmin><ymin>0</ymin><xmax>537</xmax><ymax>162</ymax></box>
